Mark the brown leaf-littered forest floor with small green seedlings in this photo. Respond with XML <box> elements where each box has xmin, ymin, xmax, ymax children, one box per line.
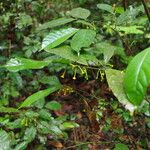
<box><xmin>47</xmin><ymin>79</ymin><xmax>150</xmax><ymax>150</ymax></box>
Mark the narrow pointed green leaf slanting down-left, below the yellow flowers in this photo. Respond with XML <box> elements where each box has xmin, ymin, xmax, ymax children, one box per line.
<box><xmin>19</xmin><ymin>86</ymin><xmax>60</xmax><ymax>109</ymax></box>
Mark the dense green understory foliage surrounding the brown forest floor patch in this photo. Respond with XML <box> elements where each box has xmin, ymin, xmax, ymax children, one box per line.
<box><xmin>0</xmin><ymin>0</ymin><xmax>150</xmax><ymax>150</ymax></box>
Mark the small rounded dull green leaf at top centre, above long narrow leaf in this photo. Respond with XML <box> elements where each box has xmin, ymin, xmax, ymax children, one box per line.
<box><xmin>69</xmin><ymin>7</ymin><xmax>91</xmax><ymax>19</ymax></box>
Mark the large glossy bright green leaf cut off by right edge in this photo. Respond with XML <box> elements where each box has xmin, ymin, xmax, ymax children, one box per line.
<box><xmin>124</xmin><ymin>48</ymin><xmax>150</xmax><ymax>105</ymax></box>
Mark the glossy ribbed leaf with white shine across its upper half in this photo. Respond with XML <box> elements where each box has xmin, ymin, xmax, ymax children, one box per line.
<box><xmin>42</xmin><ymin>28</ymin><xmax>78</xmax><ymax>49</ymax></box>
